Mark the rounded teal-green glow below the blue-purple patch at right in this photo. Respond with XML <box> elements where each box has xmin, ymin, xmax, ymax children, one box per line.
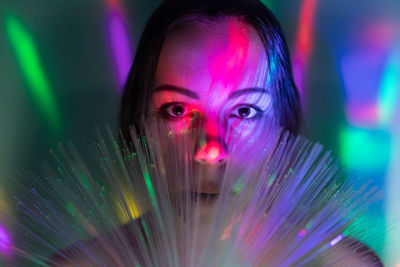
<box><xmin>339</xmin><ymin>127</ymin><xmax>391</xmax><ymax>171</ymax></box>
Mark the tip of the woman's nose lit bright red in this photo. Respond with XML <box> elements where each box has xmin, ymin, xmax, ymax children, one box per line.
<box><xmin>194</xmin><ymin>140</ymin><xmax>228</xmax><ymax>165</ymax></box>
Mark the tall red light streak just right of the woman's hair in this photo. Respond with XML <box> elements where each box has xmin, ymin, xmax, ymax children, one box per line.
<box><xmin>293</xmin><ymin>0</ymin><xmax>317</xmax><ymax>103</ymax></box>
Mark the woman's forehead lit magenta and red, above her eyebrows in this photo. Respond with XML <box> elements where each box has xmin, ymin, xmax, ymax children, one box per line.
<box><xmin>155</xmin><ymin>17</ymin><xmax>268</xmax><ymax>98</ymax></box>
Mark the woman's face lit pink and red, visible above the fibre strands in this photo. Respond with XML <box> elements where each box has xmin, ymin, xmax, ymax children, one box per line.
<box><xmin>150</xmin><ymin>17</ymin><xmax>273</xmax><ymax>193</ymax></box>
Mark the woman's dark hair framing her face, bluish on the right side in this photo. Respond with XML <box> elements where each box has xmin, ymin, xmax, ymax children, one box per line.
<box><xmin>119</xmin><ymin>0</ymin><xmax>301</xmax><ymax>140</ymax></box>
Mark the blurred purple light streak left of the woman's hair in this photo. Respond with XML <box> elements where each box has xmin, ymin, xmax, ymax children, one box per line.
<box><xmin>108</xmin><ymin>10</ymin><xmax>132</xmax><ymax>93</ymax></box>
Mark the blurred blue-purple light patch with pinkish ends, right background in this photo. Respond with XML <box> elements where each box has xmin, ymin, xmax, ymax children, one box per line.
<box><xmin>339</xmin><ymin>22</ymin><xmax>397</xmax><ymax>128</ymax></box>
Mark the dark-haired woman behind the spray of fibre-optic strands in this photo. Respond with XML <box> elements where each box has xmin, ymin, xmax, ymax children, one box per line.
<box><xmin>50</xmin><ymin>0</ymin><xmax>381</xmax><ymax>266</ymax></box>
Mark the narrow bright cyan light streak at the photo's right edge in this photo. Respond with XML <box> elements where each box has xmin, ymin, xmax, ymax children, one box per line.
<box><xmin>379</xmin><ymin>50</ymin><xmax>400</xmax><ymax>126</ymax></box>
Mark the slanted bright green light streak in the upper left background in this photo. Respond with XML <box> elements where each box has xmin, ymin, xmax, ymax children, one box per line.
<box><xmin>6</xmin><ymin>15</ymin><xmax>61</xmax><ymax>133</ymax></box>
